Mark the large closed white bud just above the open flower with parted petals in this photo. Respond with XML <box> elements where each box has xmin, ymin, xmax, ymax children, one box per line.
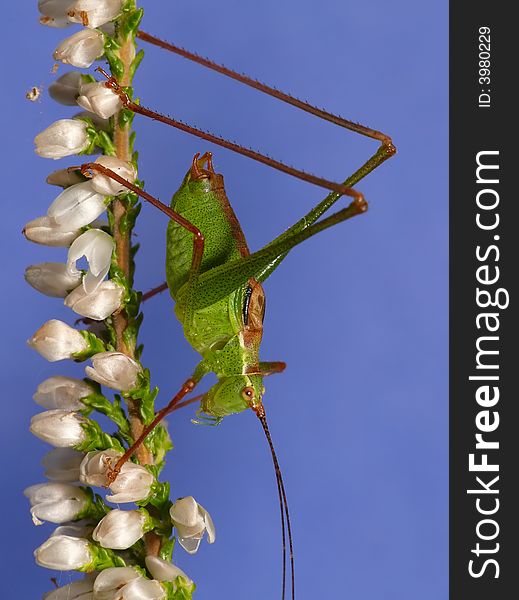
<box><xmin>47</xmin><ymin>181</ymin><xmax>106</xmax><ymax>231</ymax></box>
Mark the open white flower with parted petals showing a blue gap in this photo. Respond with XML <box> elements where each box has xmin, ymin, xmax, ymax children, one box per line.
<box><xmin>67</xmin><ymin>229</ymin><xmax>114</xmax><ymax>294</ymax></box>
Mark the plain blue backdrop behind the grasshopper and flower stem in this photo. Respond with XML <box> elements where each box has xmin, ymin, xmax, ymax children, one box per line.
<box><xmin>0</xmin><ymin>0</ymin><xmax>448</xmax><ymax>600</ymax></box>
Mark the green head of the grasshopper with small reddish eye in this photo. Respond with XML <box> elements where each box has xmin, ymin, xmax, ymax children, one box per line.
<box><xmin>201</xmin><ymin>375</ymin><xmax>265</xmax><ymax>418</ymax></box>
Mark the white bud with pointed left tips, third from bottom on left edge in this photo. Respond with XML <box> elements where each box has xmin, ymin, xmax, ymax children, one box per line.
<box><xmin>23</xmin><ymin>483</ymin><xmax>88</xmax><ymax>525</ymax></box>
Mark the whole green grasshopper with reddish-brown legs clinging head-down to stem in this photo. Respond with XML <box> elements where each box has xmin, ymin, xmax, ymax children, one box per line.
<box><xmin>81</xmin><ymin>32</ymin><xmax>395</xmax><ymax>598</ymax></box>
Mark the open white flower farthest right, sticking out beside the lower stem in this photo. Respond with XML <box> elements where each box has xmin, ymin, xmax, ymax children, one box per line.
<box><xmin>169</xmin><ymin>496</ymin><xmax>216</xmax><ymax>554</ymax></box>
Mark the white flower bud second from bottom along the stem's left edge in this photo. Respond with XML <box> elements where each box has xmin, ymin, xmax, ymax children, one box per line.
<box><xmin>34</xmin><ymin>535</ymin><xmax>93</xmax><ymax>571</ymax></box>
